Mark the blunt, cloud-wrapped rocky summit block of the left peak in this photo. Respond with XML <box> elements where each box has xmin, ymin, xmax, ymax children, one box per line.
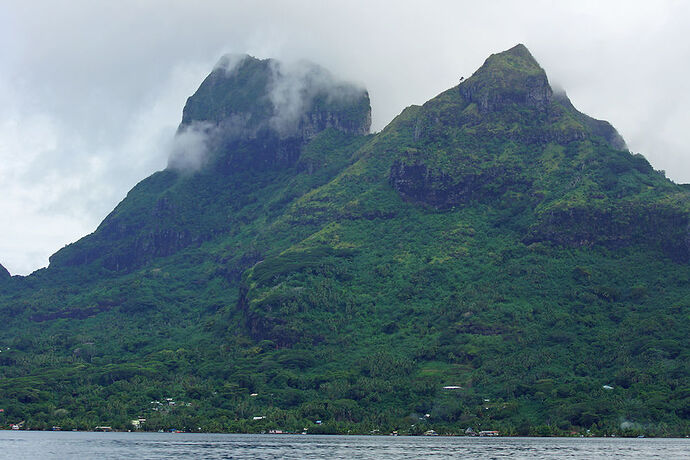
<box><xmin>170</xmin><ymin>55</ymin><xmax>371</xmax><ymax>169</ymax></box>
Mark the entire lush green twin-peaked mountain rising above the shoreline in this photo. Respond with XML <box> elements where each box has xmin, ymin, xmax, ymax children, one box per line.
<box><xmin>0</xmin><ymin>45</ymin><xmax>690</xmax><ymax>436</ymax></box>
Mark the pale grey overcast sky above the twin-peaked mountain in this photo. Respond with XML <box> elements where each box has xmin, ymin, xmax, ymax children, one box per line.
<box><xmin>0</xmin><ymin>0</ymin><xmax>690</xmax><ymax>274</ymax></box>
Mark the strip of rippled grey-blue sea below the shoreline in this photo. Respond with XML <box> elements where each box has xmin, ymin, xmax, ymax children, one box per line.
<box><xmin>0</xmin><ymin>431</ymin><xmax>690</xmax><ymax>460</ymax></box>
